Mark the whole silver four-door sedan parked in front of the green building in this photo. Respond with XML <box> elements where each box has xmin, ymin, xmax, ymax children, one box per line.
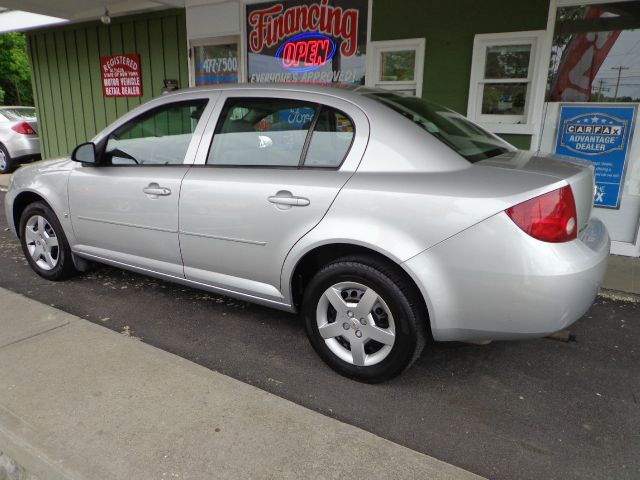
<box><xmin>5</xmin><ymin>85</ymin><xmax>610</xmax><ymax>382</ymax></box>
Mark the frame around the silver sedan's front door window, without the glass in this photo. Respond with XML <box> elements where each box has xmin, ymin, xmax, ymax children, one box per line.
<box><xmin>95</xmin><ymin>96</ymin><xmax>210</xmax><ymax>168</ymax></box>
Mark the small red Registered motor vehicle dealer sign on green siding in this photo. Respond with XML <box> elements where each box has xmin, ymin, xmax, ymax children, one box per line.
<box><xmin>100</xmin><ymin>53</ymin><xmax>142</xmax><ymax>97</ymax></box>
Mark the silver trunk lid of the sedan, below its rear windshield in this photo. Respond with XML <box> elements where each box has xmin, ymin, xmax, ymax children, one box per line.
<box><xmin>476</xmin><ymin>151</ymin><xmax>595</xmax><ymax>231</ymax></box>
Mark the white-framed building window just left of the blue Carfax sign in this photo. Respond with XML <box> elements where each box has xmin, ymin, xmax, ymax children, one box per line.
<box><xmin>467</xmin><ymin>32</ymin><xmax>544</xmax><ymax>134</ymax></box>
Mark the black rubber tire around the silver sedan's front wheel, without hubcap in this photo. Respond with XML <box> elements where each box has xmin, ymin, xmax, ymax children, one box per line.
<box><xmin>19</xmin><ymin>202</ymin><xmax>77</xmax><ymax>281</ymax></box>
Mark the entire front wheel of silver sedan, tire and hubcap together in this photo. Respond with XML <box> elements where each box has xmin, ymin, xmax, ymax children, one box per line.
<box><xmin>20</xmin><ymin>202</ymin><xmax>76</xmax><ymax>281</ymax></box>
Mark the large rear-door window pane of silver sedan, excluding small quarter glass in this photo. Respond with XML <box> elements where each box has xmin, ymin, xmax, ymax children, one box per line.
<box><xmin>207</xmin><ymin>98</ymin><xmax>317</xmax><ymax>167</ymax></box>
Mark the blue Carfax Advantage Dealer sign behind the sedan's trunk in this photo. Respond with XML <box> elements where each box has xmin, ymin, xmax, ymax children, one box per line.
<box><xmin>556</xmin><ymin>104</ymin><xmax>636</xmax><ymax>208</ymax></box>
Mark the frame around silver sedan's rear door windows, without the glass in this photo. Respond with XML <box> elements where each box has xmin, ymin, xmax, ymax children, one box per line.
<box><xmin>204</xmin><ymin>95</ymin><xmax>356</xmax><ymax>170</ymax></box>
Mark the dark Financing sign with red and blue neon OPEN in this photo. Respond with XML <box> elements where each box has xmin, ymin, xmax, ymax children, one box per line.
<box><xmin>246</xmin><ymin>0</ymin><xmax>369</xmax><ymax>85</ymax></box>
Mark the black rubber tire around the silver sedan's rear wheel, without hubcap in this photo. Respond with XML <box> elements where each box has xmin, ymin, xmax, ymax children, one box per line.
<box><xmin>302</xmin><ymin>255</ymin><xmax>428</xmax><ymax>383</ymax></box>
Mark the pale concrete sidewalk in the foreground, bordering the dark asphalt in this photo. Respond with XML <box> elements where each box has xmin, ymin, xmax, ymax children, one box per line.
<box><xmin>0</xmin><ymin>289</ymin><xmax>480</xmax><ymax>480</ymax></box>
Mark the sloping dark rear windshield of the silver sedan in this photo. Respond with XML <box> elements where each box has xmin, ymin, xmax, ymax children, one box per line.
<box><xmin>365</xmin><ymin>92</ymin><xmax>513</xmax><ymax>163</ymax></box>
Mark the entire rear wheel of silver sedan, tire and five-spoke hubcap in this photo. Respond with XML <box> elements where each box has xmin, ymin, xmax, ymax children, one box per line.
<box><xmin>303</xmin><ymin>256</ymin><xmax>426</xmax><ymax>383</ymax></box>
